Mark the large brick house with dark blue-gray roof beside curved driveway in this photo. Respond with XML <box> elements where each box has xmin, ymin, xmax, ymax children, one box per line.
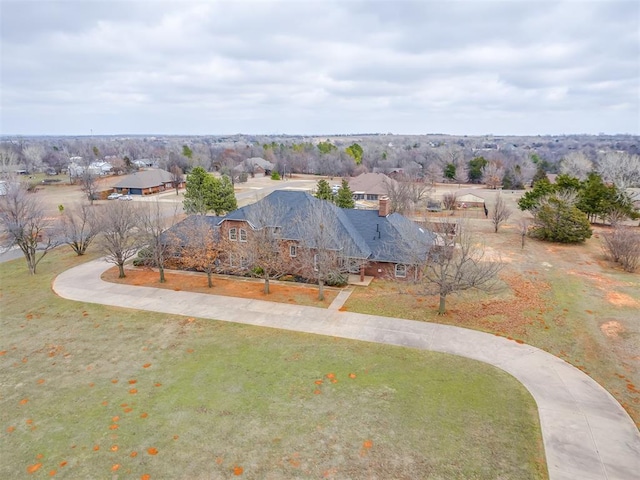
<box><xmin>167</xmin><ymin>190</ymin><xmax>435</xmax><ymax>279</ymax></box>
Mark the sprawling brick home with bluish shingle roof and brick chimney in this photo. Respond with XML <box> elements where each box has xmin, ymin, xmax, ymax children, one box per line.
<box><xmin>165</xmin><ymin>190</ymin><xmax>435</xmax><ymax>278</ymax></box>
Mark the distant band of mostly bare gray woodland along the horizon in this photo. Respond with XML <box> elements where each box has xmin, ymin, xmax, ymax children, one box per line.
<box><xmin>0</xmin><ymin>135</ymin><xmax>640</xmax><ymax>189</ymax></box>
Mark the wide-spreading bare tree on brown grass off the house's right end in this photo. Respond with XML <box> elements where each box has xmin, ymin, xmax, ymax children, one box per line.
<box><xmin>422</xmin><ymin>218</ymin><xmax>504</xmax><ymax>315</ymax></box>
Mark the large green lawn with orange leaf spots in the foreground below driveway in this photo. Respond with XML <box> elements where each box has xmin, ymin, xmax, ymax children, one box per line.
<box><xmin>0</xmin><ymin>250</ymin><xmax>547</xmax><ymax>480</ymax></box>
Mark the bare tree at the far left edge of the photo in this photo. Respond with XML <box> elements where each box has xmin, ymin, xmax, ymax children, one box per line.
<box><xmin>0</xmin><ymin>182</ymin><xmax>60</xmax><ymax>275</ymax></box>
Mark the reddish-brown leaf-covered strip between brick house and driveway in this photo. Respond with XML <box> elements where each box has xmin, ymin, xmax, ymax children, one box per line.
<box><xmin>102</xmin><ymin>267</ymin><xmax>340</xmax><ymax>308</ymax></box>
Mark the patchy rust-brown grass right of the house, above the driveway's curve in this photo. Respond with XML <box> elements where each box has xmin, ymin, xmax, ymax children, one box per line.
<box><xmin>344</xmin><ymin>220</ymin><xmax>640</xmax><ymax>425</ymax></box>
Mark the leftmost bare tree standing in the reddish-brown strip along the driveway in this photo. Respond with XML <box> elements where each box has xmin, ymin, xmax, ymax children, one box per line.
<box><xmin>98</xmin><ymin>202</ymin><xmax>144</xmax><ymax>278</ymax></box>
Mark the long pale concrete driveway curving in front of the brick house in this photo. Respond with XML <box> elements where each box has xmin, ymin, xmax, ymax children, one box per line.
<box><xmin>53</xmin><ymin>260</ymin><xmax>640</xmax><ymax>480</ymax></box>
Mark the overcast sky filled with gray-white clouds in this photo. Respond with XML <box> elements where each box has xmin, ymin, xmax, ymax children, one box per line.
<box><xmin>0</xmin><ymin>0</ymin><xmax>640</xmax><ymax>135</ymax></box>
